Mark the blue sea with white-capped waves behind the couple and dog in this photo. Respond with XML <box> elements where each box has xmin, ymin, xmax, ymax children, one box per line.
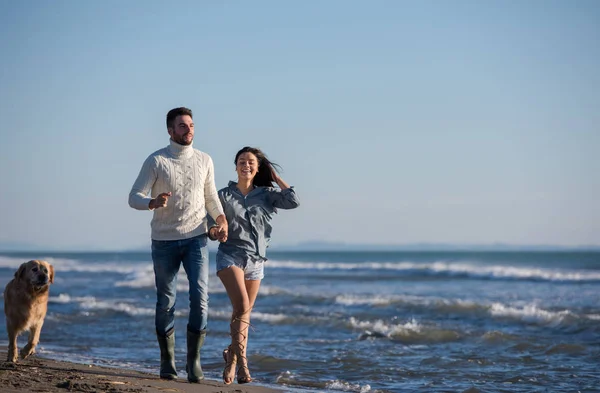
<box><xmin>0</xmin><ymin>250</ymin><xmax>600</xmax><ymax>393</ymax></box>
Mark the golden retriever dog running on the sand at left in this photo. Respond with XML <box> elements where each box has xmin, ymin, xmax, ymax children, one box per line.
<box><xmin>4</xmin><ymin>260</ymin><xmax>54</xmax><ymax>363</ymax></box>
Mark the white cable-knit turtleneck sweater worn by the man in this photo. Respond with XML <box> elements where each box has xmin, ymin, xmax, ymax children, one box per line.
<box><xmin>129</xmin><ymin>141</ymin><xmax>223</xmax><ymax>240</ymax></box>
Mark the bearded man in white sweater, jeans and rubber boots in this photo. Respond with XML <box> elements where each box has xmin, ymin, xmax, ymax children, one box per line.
<box><xmin>129</xmin><ymin>108</ymin><xmax>228</xmax><ymax>382</ymax></box>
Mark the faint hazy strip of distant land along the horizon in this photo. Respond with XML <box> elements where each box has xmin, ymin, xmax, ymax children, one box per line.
<box><xmin>0</xmin><ymin>241</ymin><xmax>600</xmax><ymax>252</ymax></box>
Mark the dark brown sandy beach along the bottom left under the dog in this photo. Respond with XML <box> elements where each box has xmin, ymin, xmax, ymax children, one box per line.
<box><xmin>0</xmin><ymin>349</ymin><xmax>278</xmax><ymax>393</ymax></box>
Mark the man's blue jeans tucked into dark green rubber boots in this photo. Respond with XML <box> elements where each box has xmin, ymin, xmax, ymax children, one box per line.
<box><xmin>152</xmin><ymin>235</ymin><xmax>209</xmax><ymax>337</ymax></box>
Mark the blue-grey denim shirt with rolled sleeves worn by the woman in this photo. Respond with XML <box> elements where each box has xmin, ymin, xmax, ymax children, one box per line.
<box><xmin>219</xmin><ymin>181</ymin><xmax>300</xmax><ymax>258</ymax></box>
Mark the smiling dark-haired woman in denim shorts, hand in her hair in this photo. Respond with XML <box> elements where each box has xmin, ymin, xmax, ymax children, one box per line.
<box><xmin>209</xmin><ymin>147</ymin><xmax>300</xmax><ymax>385</ymax></box>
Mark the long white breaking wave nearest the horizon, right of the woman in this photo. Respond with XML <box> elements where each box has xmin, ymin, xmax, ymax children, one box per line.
<box><xmin>269</xmin><ymin>260</ymin><xmax>600</xmax><ymax>282</ymax></box>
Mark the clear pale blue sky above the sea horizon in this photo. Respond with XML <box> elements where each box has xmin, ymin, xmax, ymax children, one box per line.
<box><xmin>0</xmin><ymin>0</ymin><xmax>600</xmax><ymax>250</ymax></box>
